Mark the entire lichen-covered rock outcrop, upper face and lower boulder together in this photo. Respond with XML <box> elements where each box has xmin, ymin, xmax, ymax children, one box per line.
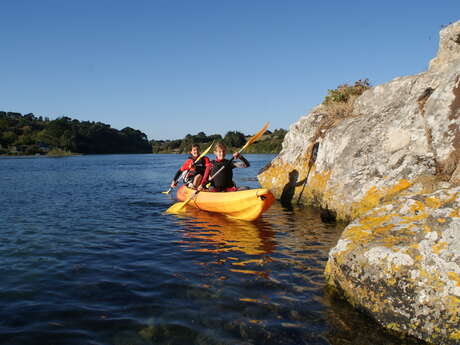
<box><xmin>259</xmin><ymin>22</ymin><xmax>460</xmax><ymax>344</ymax></box>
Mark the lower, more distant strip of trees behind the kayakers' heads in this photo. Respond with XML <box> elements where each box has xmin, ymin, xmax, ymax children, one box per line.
<box><xmin>150</xmin><ymin>129</ymin><xmax>287</xmax><ymax>153</ymax></box>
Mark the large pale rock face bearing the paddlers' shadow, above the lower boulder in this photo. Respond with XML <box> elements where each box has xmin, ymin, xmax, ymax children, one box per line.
<box><xmin>258</xmin><ymin>22</ymin><xmax>460</xmax><ymax>220</ymax></box>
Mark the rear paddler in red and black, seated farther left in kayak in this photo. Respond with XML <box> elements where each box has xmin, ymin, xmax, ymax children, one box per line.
<box><xmin>171</xmin><ymin>144</ymin><xmax>210</xmax><ymax>188</ymax></box>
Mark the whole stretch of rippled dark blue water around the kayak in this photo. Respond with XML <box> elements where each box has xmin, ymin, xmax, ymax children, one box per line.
<box><xmin>0</xmin><ymin>155</ymin><xmax>424</xmax><ymax>345</ymax></box>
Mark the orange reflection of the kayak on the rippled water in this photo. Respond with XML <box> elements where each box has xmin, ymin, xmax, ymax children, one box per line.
<box><xmin>180</xmin><ymin>208</ymin><xmax>275</xmax><ymax>255</ymax></box>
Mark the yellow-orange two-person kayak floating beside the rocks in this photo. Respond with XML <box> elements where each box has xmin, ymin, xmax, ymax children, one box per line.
<box><xmin>176</xmin><ymin>185</ymin><xmax>275</xmax><ymax>221</ymax></box>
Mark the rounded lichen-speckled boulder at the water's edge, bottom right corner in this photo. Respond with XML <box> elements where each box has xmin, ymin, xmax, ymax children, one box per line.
<box><xmin>326</xmin><ymin>187</ymin><xmax>460</xmax><ymax>344</ymax></box>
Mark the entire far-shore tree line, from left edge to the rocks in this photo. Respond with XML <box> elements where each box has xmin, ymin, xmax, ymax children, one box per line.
<box><xmin>0</xmin><ymin>111</ymin><xmax>286</xmax><ymax>155</ymax></box>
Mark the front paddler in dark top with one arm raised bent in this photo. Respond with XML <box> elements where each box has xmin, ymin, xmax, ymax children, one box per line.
<box><xmin>198</xmin><ymin>143</ymin><xmax>250</xmax><ymax>192</ymax></box>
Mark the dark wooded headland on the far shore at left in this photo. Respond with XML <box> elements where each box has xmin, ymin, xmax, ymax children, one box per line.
<box><xmin>0</xmin><ymin>111</ymin><xmax>151</xmax><ymax>156</ymax></box>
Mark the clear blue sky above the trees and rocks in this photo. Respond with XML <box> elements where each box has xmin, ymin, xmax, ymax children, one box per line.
<box><xmin>0</xmin><ymin>0</ymin><xmax>460</xmax><ymax>139</ymax></box>
